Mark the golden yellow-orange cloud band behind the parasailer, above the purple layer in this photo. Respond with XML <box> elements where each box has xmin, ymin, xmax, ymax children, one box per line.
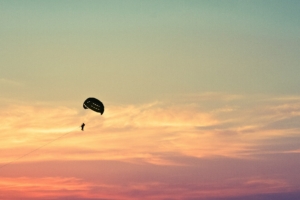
<box><xmin>0</xmin><ymin>93</ymin><xmax>300</xmax><ymax>165</ymax></box>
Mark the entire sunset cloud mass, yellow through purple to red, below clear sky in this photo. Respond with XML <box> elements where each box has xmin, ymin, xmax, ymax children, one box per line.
<box><xmin>0</xmin><ymin>93</ymin><xmax>300</xmax><ymax>199</ymax></box>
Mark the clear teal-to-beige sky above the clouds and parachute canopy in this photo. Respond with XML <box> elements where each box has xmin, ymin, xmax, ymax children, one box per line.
<box><xmin>0</xmin><ymin>1</ymin><xmax>300</xmax><ymax>102</ymax></box>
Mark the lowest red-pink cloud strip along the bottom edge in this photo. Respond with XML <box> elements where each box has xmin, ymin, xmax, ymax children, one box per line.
<box><xmin>0</xmin><ymin>177</ymin><xmax>288</xmax><ymax>200</ymax></box>
